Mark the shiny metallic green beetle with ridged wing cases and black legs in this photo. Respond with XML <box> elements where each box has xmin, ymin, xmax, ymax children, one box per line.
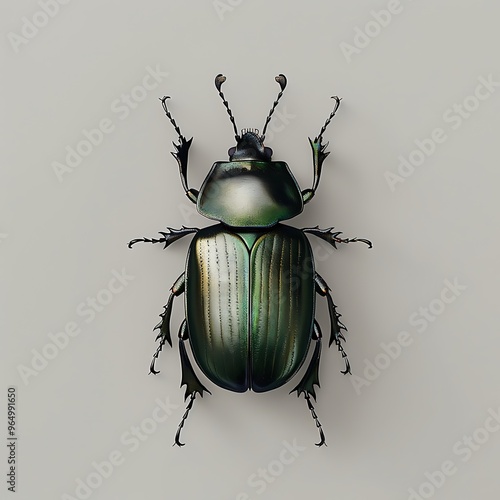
<box><xmin>128</xmin><ymin>74</ymin><xmax>372</xmax><ymax>446</ymax></box>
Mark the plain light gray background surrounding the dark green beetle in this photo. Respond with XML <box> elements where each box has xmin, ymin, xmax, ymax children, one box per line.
<box><xmin>0</xmin><ymin>0</ymin><xmax>500</xmax><ymax>500</ymax></box>
